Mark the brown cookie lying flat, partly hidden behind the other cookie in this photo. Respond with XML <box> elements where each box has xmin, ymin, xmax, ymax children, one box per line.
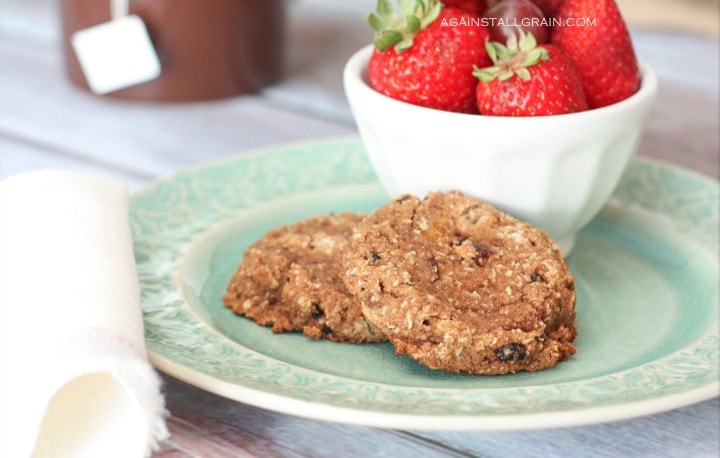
<box><xmin>223</xmin><ymin>213</ymin><xmax>385</xmax><ymax>343</ymax></box>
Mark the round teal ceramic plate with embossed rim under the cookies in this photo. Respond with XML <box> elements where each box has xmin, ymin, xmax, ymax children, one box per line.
<box><xmin>130</xmin><ymin>137</ymin><xmax>720</xmax><ymax>430</ymax></box>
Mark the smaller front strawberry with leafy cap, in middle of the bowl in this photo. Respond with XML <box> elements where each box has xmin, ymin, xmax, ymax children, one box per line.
<box><xmin>474</xmin><ymin>30</ymin><xmax>588</xmax><ymax>116</ymax></box>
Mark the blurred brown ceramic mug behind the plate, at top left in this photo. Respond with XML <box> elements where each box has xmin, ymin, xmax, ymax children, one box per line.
<box><xmin>61</xmin><ymin>0</ymin><xmax>285</xmax><ymax>102</ymax></box>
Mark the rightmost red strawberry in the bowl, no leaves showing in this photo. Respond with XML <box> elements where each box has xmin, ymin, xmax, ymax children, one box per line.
<box><xmin>551</xmin><ymin>0</ymin><xmax>640</xmax><ymax>108</ymax></box>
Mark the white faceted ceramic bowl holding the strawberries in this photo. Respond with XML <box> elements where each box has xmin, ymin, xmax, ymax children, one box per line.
<box><xmin>343</xmin><ymin>46</ymin><xmax>657</xmax><ymax>255</ymax></box>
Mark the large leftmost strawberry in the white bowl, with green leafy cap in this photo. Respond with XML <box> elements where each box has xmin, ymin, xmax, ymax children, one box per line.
<box><xmin>368</xmin><ymin>0</ymin><xmax>490</xmax><ymax>113</ymax></box>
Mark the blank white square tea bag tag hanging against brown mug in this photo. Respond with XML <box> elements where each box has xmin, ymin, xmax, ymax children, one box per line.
<box><xmin>71</xmin><ymin>15</ymin><xmax>160</xmax><ymax>94</ymax></box>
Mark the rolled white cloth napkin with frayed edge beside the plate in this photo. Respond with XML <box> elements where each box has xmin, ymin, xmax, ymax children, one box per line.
<box><xmin>0</xmin><ymin>171</ymin><xmax>167</xmax><ymax>458</ymax></box>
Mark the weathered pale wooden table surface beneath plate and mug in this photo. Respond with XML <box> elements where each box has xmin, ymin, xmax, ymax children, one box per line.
<box><xmin>0</xmin><ymin>0</ymin><xmax>720</xmax><ymax>458</ymax></box>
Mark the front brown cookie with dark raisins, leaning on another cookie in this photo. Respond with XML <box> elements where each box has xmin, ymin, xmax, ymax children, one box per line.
<box><xmin>343</xmin><ymin>192</ymin><xmax>576</xmax><ymax>374</ymax></box>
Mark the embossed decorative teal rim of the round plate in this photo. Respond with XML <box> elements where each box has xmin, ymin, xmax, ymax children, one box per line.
<box><xmin>131</xmin><ymin>137</ymin><xmax>720</xmax><ymax>430</ymax></box>
